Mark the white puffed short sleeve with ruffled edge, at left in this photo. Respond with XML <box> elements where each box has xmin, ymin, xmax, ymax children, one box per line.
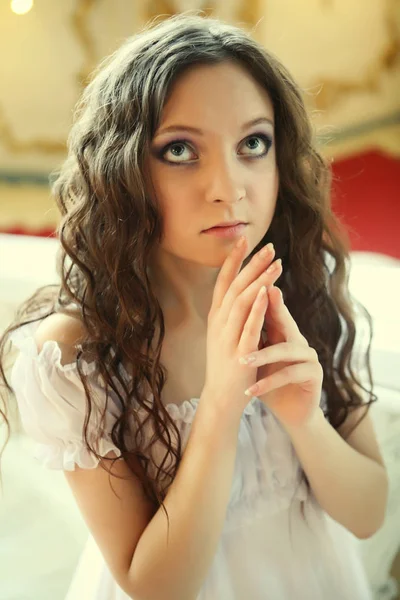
<box><xmin>9</xmin><ymin>322</ymin><xmax>121</xmax><ymax>471</ymax></box>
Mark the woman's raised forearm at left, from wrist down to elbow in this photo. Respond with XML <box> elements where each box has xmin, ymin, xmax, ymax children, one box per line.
<box><xmin>130</xmin><ymin>394</ymin><xmax>240</xmax><ymax>600</ymax></box>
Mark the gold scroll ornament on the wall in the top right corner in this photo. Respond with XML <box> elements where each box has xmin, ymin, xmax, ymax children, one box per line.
<box><xmin>311</xmin><ymin>0</ymin><xmax>400</xmax><ymax>111</ymax></box>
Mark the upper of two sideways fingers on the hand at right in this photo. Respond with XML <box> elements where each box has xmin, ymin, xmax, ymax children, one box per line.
<box><xmin>239</xmin><ymin>342</ymin><xmax>318</xmax><ymax>367</ymax></box>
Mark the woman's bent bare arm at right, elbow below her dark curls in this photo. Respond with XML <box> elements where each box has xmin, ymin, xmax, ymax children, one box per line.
<box><xmin>287</xmin><ymin>409</ymin><xmax>389</xmax><ymax>539</ymax></box>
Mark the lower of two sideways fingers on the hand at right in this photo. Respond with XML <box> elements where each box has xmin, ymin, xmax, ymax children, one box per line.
<box><xmin>246</xmin><ymin>362</ymin><xmax>323</xmax><ymax>395</ymax></box>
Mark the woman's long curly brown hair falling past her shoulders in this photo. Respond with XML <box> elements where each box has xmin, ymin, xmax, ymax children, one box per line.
<box><xmin>0</xmin><ymin>14</ymin><xmax>377</xmax><ymax>528</ymax></box>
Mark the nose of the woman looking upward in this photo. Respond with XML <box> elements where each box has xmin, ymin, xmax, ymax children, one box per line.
<box><xmin>201</xmin><ymin>156</ymin><xmax>246</xmax><ymax>203</ymax></box>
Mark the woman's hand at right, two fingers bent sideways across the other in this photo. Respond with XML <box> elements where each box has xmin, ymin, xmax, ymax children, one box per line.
<box><xmin>239</xmin><ymin>286</ymin><xmax>323</xmax><ymax>429</ymax></box>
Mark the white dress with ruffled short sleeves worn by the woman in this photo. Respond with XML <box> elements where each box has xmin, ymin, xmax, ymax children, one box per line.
<box><xmin>7</xmin><ymin>323</ymin><xmax>372</xmax><ymax>600</ymax></box>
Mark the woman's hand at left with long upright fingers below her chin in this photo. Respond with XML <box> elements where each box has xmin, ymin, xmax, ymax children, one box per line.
<box><xmin>201</xmin><ymin>238</ymin><xmax>282</xmax><ymax>417</ymax></box>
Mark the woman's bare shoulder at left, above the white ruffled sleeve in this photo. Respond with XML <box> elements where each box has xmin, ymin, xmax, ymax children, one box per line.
<box><xmin>34</xmin><ymin>313</ymin><xmax>85</xmax><ymax>365</ymax></box>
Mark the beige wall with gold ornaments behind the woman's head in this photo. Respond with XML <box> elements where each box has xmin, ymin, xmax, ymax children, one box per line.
<box><xmin>0</xmin><ymin>0</ymin><xmax>400</xmax><ymax>178</ymax></box>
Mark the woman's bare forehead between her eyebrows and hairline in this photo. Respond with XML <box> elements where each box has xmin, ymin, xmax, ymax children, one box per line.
<box><xmin>160</xmin><ymin>62</ymin><xmax>274</xmax><ymax>130</ymax></box>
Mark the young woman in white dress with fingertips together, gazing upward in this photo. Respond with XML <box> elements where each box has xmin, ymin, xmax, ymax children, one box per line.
<box><xmin>1</xmin><ymin>10</ymin><xmax>387</xmax><ymax>600</ymax></box>
